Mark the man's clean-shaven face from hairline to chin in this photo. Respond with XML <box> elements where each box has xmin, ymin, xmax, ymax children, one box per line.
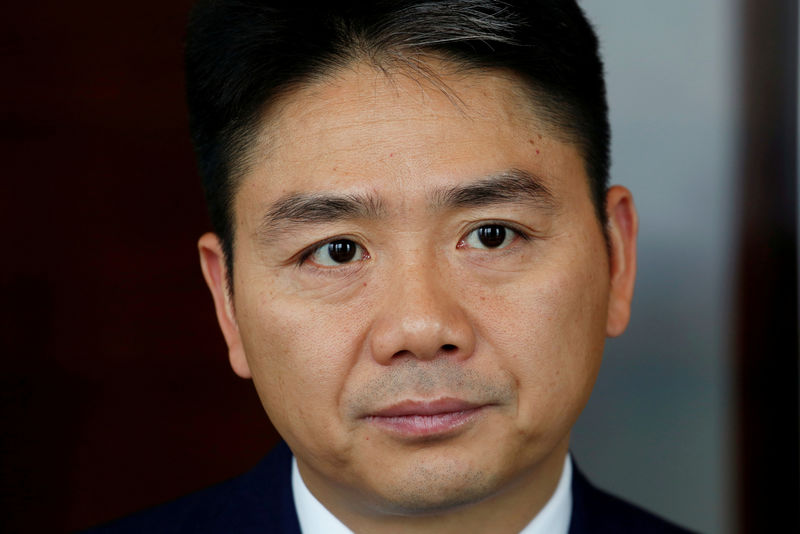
<box><xmin>201</xmin><ymin>60</ymin><xmax>635</xmax><ymax>514</ymax></box>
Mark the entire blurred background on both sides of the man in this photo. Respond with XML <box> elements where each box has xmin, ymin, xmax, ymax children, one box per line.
<box><xmin>0</xmin><ymin>0</ymin><xmax>800</xmax><ymax>534</ymax></box>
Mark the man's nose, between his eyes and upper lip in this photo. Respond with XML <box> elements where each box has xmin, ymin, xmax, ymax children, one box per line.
<box><xmin>369</xmin><ymin>262</ymin><xmax>475</xmax><ymax>365</ymax></box>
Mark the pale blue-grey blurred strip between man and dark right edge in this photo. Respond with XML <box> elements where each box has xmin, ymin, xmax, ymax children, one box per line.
<box><xmin>573</xmin><ymin>0</ymin><xmax>741</xmax><ymax>533</ymax></box>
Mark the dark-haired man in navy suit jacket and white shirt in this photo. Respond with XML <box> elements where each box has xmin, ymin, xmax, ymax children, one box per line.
<box><xmin>92</xmin><ymin>0</ymin><xmax>684</xmax><ymax>534</ymax></box>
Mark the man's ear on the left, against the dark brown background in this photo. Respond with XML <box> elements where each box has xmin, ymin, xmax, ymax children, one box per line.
<box><xmin>197</xmin><ymin>233</ymin><xmax>251</xmax><ymax>378</ymax></box>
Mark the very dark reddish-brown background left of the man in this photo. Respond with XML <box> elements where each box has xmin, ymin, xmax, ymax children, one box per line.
<box><xmin>0</xmin><ymin>0</ymin><xmax>275</xmax><ymax>533</ymax></box>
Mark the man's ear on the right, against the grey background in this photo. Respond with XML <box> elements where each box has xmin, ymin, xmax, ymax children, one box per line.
<box><xmin>606</xmin><ymin>185</ymin><xmax>639</xmax><ymax>337</ymax></box>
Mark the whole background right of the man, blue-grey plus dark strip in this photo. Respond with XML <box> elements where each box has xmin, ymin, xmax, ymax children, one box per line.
<box><xmin>573</xmin><ymin>0</ymin><xmax>800</xmax><ymax>533</ymax></box>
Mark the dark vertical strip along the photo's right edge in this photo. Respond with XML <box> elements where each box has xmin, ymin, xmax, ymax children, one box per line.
<box><xmin>737</xmin><ymin>0</ymin><xmax>800</xmax><ymax>533</ymax></box>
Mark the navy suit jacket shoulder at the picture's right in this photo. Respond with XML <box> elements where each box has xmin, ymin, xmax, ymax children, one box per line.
<box><xmin>569</xmin><ymin>463</ymin><xmax>692</xmax><ymax>534</ymax></box>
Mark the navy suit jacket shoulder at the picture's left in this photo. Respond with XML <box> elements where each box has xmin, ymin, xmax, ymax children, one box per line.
<box><xmin>86</xmin><ymin>443</ymin><xmax>300</xmax><ymax>534</ymax></box>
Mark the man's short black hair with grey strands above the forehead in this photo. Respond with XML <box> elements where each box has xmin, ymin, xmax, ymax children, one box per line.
<box><xmin>186</xmin><ymin>0</ymin><xmax>610</xmax><ymax>291</ymax></box>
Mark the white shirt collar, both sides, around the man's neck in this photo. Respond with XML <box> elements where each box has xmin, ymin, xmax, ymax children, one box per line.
<box><xmin>292</xmin><ymin>454</ymin><xmax>572</xmax><ymax>534</ymax></box>
